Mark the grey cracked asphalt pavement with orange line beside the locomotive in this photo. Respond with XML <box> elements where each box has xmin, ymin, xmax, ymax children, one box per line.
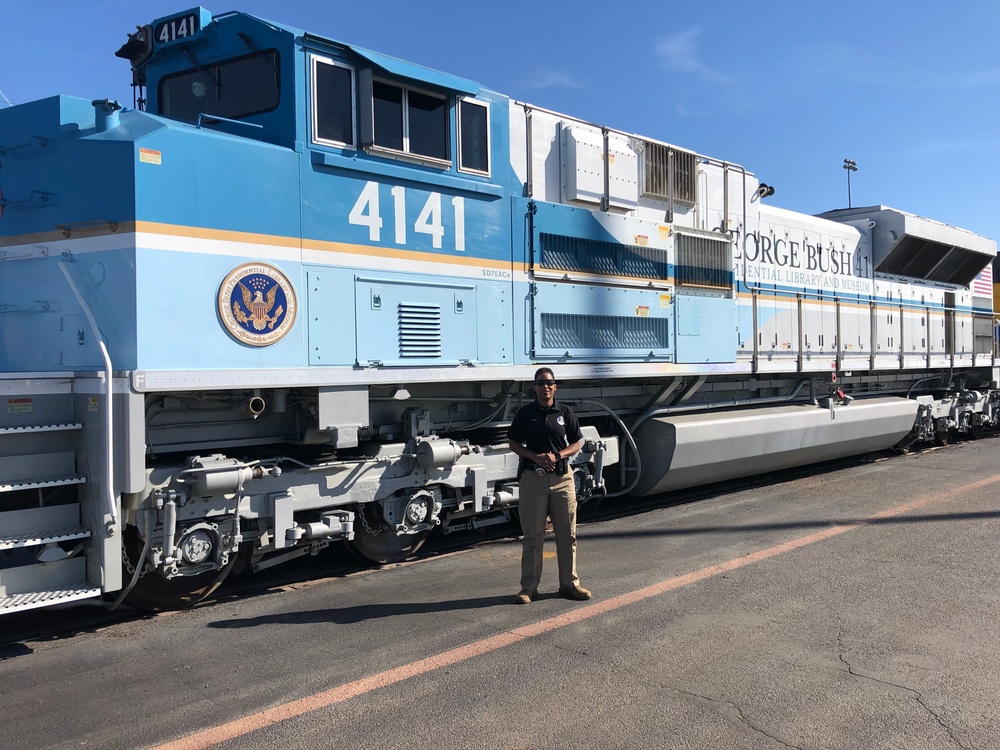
<box><xmin>0</xmin><ymin>438</ymin><xmax>1000</xmax><ymax>750</ymax></box>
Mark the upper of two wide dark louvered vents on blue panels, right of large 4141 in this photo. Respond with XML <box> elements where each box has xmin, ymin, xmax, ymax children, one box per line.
<box><xmin>538</xmin><ymin>232</ymin><xmax>670</xmax><ymax>280</ymax></box>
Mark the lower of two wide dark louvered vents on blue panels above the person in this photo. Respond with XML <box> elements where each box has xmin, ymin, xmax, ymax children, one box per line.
<box><xmin>541</xmin><ymin>313</ymin><xmax>670</xmax><ymax>351</ymax></box>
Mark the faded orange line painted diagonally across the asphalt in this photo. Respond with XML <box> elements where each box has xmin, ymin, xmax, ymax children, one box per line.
<box><xmin>153</xmin><ymin>474</ymin><xmax>1000</xmax><ymax>750</ymax></box>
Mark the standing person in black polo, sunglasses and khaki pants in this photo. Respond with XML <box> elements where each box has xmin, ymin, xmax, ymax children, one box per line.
<box><xmin>507</xmin><ymin>367</ymin><xmax>590</xmax><ymax>604</ymax></box>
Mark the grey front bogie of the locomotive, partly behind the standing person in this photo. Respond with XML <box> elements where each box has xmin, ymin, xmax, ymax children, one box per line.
<box><xmin>126</xmin><ymin>409</ymin><xmax>617</xmax><ymax>579</ymax></box>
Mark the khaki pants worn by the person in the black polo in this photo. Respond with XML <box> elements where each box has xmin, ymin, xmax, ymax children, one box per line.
<box><xmin>517</xmin><ymin>470</ymin><xmax>580</xmax><ymax>592</ymax></box>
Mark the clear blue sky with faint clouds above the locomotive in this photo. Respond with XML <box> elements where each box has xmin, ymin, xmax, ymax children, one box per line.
<box><xmin>0</xmin><ymin>0</ymin><xmax>1000</xmax><ymax>245</ymax></box>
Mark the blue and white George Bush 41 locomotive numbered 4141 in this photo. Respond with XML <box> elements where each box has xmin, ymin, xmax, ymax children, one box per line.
<box><xmin>0</xmin><ymin>8</ymin><xmax>1000</xmax><ymax>614</ymax></box>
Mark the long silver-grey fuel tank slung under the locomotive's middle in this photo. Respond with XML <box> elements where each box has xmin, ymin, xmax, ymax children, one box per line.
<box><xmin>630</xmin><ymin>398</ymin><xmax>918</xmax><ymax>496</ymax></box>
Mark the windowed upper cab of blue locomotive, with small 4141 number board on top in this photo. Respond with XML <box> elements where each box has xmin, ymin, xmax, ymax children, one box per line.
<box><xmin>116</xmin><ymin>7</ymin><xmax>502</xmax><ymax>187</ymax></box>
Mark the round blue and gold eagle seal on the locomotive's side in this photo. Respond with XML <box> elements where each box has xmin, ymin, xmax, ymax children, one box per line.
<box><xmin>219</xmin><ymin>263</ymin><xmax>296</xmax><ymax>346</ymax></box>
